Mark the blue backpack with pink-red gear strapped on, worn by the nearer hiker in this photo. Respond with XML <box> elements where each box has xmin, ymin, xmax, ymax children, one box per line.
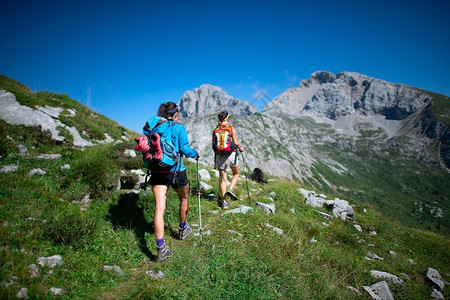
<box><xmin>135</xmin><ymin>117</ymin><xmax>181</xmax><ymax>170</ymax></box>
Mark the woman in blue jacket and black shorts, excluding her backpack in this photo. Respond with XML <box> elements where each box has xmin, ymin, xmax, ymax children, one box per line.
<box><xmin>150</xmin><ymin>102</ymin><xmax>200</xmax><ymax>261</ymax></box>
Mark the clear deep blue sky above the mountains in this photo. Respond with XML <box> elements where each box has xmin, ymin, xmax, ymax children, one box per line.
<box><xmin>0</xmin><ymin>0</ymin><xmax>450</xmax><ymax>132</ymax></box>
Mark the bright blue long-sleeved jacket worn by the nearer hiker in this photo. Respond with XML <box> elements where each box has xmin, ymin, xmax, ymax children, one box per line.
<box><xmin>153</xmin><ymin>121</ymin><xmax>198</xmax><ymax>173</ymax></box>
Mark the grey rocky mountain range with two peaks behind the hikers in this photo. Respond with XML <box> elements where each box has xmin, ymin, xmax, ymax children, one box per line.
<box><xmin>179</xmin><ymin>71</ymin><xmax>450</xmax><ymax>234</ymax></box>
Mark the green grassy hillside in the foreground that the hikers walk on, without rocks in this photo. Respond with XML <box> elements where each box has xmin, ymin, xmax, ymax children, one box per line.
<box><xmin>0</xmin><ymin>77</ymin><xmax>450</xmax><ymax>299</ymax></box>
